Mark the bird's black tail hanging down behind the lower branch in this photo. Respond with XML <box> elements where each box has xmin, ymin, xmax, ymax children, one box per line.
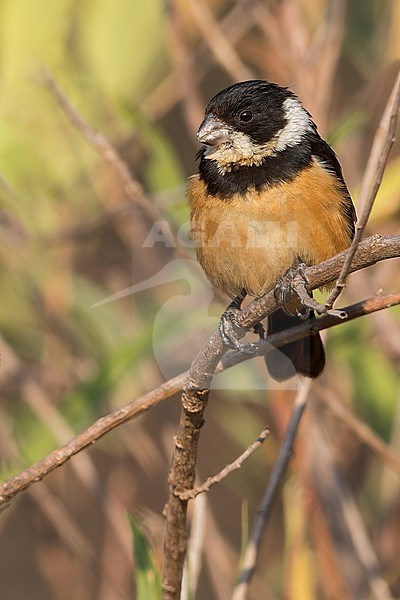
<box><xmin>264</xmin><ymin>309</ymin><xmax>325</xmax><ymax>381</ymax></box>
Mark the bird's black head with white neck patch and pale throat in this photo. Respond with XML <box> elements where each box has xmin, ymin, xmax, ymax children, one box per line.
<box><xmin>197</xmin><ymin>80</ymin><xmax>316</xmax><ymax>172</ymax></box>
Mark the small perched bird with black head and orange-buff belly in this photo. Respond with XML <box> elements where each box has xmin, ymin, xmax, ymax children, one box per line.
<box><xmin>188</xmin><ymin>80</ymin><xmax>356</xmax><ymax>381</ymax></box>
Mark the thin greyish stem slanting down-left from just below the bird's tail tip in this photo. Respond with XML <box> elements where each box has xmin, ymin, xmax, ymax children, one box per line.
<box><xmin>232</xmin><ymin>379</ymin><xmax>313</xmax><ymax>600</ymax></box>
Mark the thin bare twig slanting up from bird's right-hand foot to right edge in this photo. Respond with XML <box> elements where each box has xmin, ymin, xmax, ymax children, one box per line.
<box><xmin>326</xmin><ymin>72</ymin><xmax>400</xmax><ymax>308</ymax></box>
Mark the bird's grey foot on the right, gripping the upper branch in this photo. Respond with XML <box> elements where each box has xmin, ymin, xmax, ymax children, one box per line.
<box><xmin>274</xmin><ymin>262</ymin><xmax>347</xmax><ymax>319</ymax></box>
